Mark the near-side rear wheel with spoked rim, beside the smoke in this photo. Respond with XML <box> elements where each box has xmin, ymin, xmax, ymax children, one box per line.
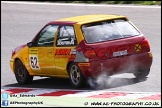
<box><xmin>68</xmin><ymin>63</ymin><xmax>86</xmax><ymax>88</ymax></box>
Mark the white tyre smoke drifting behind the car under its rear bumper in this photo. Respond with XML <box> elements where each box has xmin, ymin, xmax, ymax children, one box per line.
<box><xmin>88</xmin><ymin>55</ymin><xmax>144</xmax><ymax>89</ymax></box>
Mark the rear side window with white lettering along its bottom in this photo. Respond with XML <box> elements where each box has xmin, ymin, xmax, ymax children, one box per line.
<box><xmin>56</xmin><ymin>25</ymin><xmax>77</xmax><ymax>46</ymax></box>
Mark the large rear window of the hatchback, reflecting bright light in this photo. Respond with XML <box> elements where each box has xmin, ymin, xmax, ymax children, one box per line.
<box><xmin>82</xmin><ymin>19</ymin><xmax>140</xmax><ymax>43</ymax></box>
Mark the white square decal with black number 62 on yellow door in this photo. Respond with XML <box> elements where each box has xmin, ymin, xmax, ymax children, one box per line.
<box><xmin>29</xmin><ymin>55</ymin><xmax>40</xmax><ymax>69</ymax></box>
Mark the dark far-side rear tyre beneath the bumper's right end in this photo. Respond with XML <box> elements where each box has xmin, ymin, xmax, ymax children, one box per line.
<box><xmin>133</xmin><ymin>68</ymin><xmax>150</xmax><ymax>79</ymax></box>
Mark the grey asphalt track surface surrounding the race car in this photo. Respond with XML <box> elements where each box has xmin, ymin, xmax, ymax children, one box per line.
<box><xmin>1</xmin><ymin>2</ymin><xmax>161</xmax><ymax>92</ymax></box>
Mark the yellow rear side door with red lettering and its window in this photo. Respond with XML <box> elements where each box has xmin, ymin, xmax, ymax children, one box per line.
<box><xmin>55</xmin><ymin>25</ymin><xmax>77</xmax><ymax>77</ymax></box>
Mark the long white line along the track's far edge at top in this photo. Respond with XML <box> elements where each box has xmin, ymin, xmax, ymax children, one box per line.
<box><xmin>1</xmin><ymin>1</ymin><xmax>161</xmax><ymax>8</ymax></box>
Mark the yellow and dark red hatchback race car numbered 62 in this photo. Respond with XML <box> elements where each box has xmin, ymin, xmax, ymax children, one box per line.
<box><xmin>10</xmin><ymin>14</ymin><xmax>152</xmax><ymax>88</ymax></box>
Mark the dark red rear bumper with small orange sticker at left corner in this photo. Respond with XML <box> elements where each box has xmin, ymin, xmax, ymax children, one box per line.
<box><xmin>77</xmin><ymin>52</ymin><xmax>153</xmax><ymax>78</ymax></box>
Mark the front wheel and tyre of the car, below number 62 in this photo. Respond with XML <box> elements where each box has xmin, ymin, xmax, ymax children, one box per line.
<box><xmin>15</xmin><ymin>60</ymin><xmax>33</xmax><ymax>84</ymax></box>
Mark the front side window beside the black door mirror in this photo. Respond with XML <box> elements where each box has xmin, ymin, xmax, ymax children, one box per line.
<box><xmin>36</xmin><ymin>25</ymin><xmax>58</xmax><ymax>46</ymax></box>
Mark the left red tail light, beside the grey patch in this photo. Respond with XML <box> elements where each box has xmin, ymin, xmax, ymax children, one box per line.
<box><xmin>84</xmin><ymin>48</ymin><xmax>96</xmax><ymax>59</ymax></box>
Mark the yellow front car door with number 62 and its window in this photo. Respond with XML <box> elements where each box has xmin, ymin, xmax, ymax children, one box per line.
<box><xmin>29</xmin><ymin>25</ymin><xmax>58</xmax><ymax>75</ymax></box>
